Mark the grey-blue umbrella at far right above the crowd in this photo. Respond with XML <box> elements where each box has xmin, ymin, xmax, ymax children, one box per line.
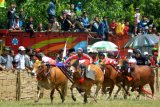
<box><xmin>124</xmin><ymin>34</ymin><xmax>159</xmax><ymax>48</ymax></box>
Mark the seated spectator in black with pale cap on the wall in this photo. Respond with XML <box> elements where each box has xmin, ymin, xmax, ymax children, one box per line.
<box><xmin>62</xmin><ymin>12</ymin><xmax>74</xmax><ymax>31</ymax></box>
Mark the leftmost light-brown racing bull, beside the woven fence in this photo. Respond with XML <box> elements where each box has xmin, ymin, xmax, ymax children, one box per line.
<box><xmin>32</xmin><ymin>61</ymin><xmax>68</xmax><ymax>103</ymax></box>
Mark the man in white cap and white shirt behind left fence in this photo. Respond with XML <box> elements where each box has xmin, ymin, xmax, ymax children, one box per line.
<box><xmin>14</xmin><ymin>46</ymin><xmax>26</xmax><ymax>70</ymax></box>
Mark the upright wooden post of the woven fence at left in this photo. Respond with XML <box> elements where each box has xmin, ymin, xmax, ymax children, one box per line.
<box><xmin>16</xmin><ymin>70</ymin><xmax>21</xmax><ymax>101</ymax></box>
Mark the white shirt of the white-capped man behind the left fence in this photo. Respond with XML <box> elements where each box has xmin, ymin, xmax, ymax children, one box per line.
<box><xmin>14</xmin><ymin>54</ymin><xmax>25</xmax><ymax>70</ymax></box>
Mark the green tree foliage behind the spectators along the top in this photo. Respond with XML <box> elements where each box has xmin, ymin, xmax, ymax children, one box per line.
<box><xmin>0</xmin><ymin>0</ymin><xmax>160</xmax><ymax>30</ymax></box>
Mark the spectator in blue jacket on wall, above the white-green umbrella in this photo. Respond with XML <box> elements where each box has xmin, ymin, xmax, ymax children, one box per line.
<box><xmin>98</xmin><ymin>16</ymin><xmax>109</xmax><ymax>40</ymax></box>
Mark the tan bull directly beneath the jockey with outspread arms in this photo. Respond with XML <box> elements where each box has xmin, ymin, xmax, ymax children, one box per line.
<box><xmin>70</xmin><ymin>60</ymin><xmax>104</xmax><ymax>103</ymax></box>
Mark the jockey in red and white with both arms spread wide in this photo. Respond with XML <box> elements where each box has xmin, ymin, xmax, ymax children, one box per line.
<box><xmin>64</xmin><ymin>48</ymin><xmax>93</xmax><ymax>77</ymax></box>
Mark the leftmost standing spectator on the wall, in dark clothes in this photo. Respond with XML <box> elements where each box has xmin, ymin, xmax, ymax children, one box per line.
<box><xmin>7</xmin><ymin>2</ymin><xmax>16</xmax><ymax>29</ymax></box>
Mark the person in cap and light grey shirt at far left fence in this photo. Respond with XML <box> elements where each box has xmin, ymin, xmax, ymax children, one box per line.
<box><xmin>2</xmin><ymin>46</ymin><xmax>13</xmax><ymax>70</ymax></box>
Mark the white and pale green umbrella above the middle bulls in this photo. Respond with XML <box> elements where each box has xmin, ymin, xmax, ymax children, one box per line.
<box><xmin>91</xmin><ymin>41</ymin><xmax>118</xmax><ymax>52</ymax></box>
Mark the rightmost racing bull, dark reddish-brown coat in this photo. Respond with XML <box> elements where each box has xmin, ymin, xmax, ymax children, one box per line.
<box><xmin>118</xmin><ymin>59</ymin><xmax>155</xmax><ymax>98</ymax></box>
